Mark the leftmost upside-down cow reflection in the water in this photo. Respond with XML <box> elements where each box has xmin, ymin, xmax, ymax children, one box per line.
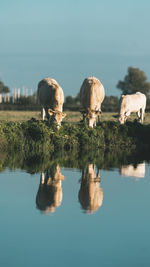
<box><xmin>36</xmin><ymin>165</ymin><xmax>64</xmax><ymax>213</ymax></box>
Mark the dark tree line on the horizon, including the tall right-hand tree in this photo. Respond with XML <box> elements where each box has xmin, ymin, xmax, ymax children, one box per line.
<box><xmin>0</xmin><ymin>67</ymin><xmax>150</xmax><ymax>112</ymax></box>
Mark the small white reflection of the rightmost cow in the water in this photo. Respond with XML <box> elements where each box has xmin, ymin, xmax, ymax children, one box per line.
<box><xmin>120</xmin><ymin>162</ymin><xmax>145</xmax><ymax>178</ymax></box>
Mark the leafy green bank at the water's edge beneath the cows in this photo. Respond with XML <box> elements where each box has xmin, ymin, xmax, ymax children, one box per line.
<box><xmin>0</xmin><ymin>118</ymin><xmax>150</xmax><ymax>152</ymax></box>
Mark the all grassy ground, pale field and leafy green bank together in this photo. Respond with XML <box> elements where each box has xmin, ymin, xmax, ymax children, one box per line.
<box><xmin>0</xmin><ymin>111</ymin><xmax>150</xmax><ymax>161</ymax></box>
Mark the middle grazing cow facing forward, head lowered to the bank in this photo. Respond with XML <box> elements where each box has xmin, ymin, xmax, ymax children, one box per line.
<box><xmin>80</xmin><ymin>76</ymin><xmax>105</xmax><ymax>128</ymax></box>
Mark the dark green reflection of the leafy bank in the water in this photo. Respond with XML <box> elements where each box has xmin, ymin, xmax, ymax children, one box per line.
<box><xmin>0</xmin><ymin>146</ymin><xmax>150</xmax><ymax>174</ymax></box>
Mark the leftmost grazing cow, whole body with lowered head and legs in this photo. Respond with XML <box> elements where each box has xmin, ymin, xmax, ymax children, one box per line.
<box><xmin>37</xmin><ymin>78</ymin><xmax>66</xmax><ymax>129</ymax></box>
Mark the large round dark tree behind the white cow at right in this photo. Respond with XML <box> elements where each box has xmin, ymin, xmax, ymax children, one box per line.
<box><xmin>117</xmin><ymin>67</ymin><xmax>150</xmax><ymax>96</ymax></box>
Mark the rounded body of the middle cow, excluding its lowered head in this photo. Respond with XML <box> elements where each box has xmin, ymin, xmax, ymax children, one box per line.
<box><xmin>80</xmin><ymin>77</ymin><xmax>105</xmax><ymax>110</ymax></box>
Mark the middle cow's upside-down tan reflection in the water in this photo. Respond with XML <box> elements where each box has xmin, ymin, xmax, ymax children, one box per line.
<box><xmin>78</xmin><ymin>164</ymin><xmax>103</xmax><ymax>213</ymax></box>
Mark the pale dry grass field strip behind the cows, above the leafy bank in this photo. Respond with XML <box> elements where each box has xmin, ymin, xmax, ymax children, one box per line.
<box><xmin>0</xmin><ymin>111</ymin><xmax>150</xmax><ymax>124</ymax></box>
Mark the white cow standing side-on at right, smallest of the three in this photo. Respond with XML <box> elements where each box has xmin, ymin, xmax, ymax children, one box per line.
<box><xmin>119</xmin><ymin>92</ymin><xmax>146</xmax><ymax>124</ymax></box>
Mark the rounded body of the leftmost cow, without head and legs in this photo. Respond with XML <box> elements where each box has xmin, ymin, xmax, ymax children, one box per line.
<box><xmin>38</xmin><ymin>78</ymin><xmax>64</xmax><ymax>111</ymax></box>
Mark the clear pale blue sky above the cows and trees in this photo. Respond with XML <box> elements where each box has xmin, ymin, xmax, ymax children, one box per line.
<box><xmin>0</xmin><ymin>0</ymin><xmax>150</xmax><ymax>95</ymax></box>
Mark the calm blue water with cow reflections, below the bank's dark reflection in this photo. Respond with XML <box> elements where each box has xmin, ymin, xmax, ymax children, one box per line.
<box><xmin>0</xmin><ymin>163</ymin><xmax>150</xmax><ymax>267</ymax></box>
